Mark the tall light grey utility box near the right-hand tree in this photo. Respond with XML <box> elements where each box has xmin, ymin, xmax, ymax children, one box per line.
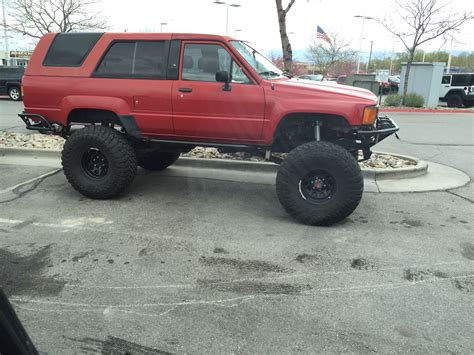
<box><xmin>399</xmin><ymin>62</ymin><xmax>446</xmax><ymax>107</ymax></box>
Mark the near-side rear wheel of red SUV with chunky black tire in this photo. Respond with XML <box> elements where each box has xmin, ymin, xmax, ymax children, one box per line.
<box><xmin>62</xmin><ymin>126</ymin><xmax>137</xmax><ymax>199</ymax></box>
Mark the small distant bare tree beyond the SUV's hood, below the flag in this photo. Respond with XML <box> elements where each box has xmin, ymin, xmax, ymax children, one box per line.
<box><xmin>307</xmin><ymin>33</ymin><xmax>355</xmax><ymax>76</ymax></box>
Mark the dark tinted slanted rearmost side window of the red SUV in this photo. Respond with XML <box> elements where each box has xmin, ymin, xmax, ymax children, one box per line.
<box><xmin>43</xmin><ymin>33</ymin><xmax>102</xmax><ymax>67</ymax></box>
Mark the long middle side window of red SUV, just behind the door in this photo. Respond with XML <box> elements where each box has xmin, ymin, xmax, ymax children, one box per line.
<box><xmin>94</xmin><ymin>41</ymin><xmax>167</xmax><ymax>79</ymax></box>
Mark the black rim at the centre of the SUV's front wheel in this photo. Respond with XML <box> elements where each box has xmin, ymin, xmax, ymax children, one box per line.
<box><xmin>299</xmin><ymin>170</ymin><xmax>336</xmax><ymax>203</ymax></box>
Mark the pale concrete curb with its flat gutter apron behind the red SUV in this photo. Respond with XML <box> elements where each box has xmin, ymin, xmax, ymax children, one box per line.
<box><xmin>0</xmin><ymin>148</ymin><xmax>470</xmax><ymax>193</ymax></box>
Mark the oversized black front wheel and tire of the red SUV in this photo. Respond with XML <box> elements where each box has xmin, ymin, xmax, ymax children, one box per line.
<box><xmin>276</xmin><ymin>142</ymin><xmax>364</xmax><ymax>225</ymax></box>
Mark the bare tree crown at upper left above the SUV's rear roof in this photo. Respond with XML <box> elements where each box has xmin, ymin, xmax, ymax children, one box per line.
<box><xmin>7</xmin><ymin>0</ymin><xmax>106</xmax><ymax>39</ymax></box>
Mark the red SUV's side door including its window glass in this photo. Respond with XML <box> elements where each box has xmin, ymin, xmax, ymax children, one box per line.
<box><xmin>172</xmin><ymin>41</ymin><xmax>265</xmax><ymax>142</ymax></box>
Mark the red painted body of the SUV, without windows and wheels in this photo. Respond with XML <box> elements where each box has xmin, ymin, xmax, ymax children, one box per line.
<box><xmin>22</xmin><ymin>33</ymin><xmax>377</xmax><ymax>146</ymax></box>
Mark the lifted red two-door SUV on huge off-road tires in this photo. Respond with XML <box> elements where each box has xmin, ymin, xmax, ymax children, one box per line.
<box><xmin>19</xmin><ymin>33</ymin><xmax>398</xmax><ymax>225</ymax></box>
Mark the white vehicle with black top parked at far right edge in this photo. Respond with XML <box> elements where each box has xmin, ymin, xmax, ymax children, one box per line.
<box><xmin>439</xmin><ymin>73</ymin><xmax>474</xmax><ymax>107</ymax></box>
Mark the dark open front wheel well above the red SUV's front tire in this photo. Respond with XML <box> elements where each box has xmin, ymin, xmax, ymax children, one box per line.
<box><xmin>272</xmin><ymin>113</ymin><xmax>352</xmax><ymax>152</ymax></box>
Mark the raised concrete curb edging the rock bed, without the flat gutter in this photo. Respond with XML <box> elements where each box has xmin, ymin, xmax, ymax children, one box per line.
<box><xmin>0</xmin><ymin>147</ymin><xmax>428</xmax><ymax>180</ymax></box>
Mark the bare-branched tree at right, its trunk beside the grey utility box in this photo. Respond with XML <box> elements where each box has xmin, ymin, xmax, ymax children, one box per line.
<box><xmin>377</xmin><ymin>0</ymin><xmax>473</xmax><ymax>103</ymax></box>
